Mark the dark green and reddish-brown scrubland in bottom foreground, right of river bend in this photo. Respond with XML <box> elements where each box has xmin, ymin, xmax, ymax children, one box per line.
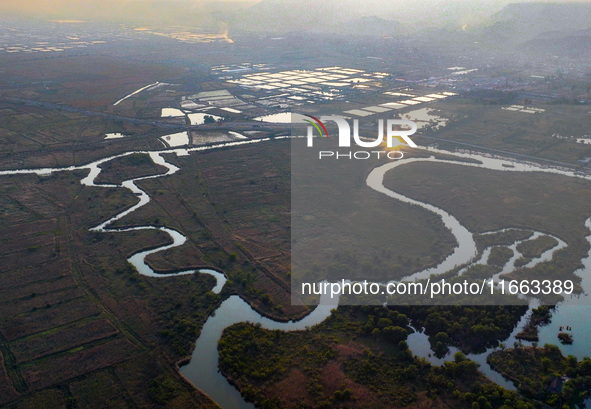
<box><xmin>218</xmin><ymin>306</ymin><xmax>534</xmax><ymax>409</ymax></box>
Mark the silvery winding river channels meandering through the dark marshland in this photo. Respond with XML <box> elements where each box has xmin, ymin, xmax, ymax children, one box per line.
<box><xmin>0</xmin><ymin>141</ymin><xmax>591</xmax><ymax>409</ymax></box>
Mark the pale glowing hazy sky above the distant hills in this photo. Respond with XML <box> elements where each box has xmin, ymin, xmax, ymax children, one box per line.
<box><xmin>0</xmin><ymin>0</ymin><xmax>591</xmax><ymax>30</ymax></box>
